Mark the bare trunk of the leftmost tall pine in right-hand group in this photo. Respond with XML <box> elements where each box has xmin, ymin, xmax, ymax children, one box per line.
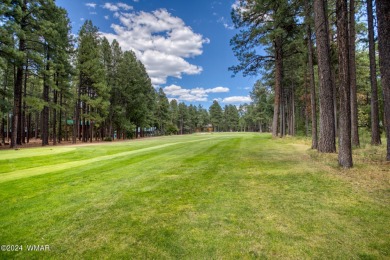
<box><xmin>272</xmin><ymin>37</ymin><xmax>283</xmax><ymax>137</ymax></box>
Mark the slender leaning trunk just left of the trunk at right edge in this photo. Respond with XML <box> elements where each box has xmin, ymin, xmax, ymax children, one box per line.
<box><xmin>367</xmin><ymin>0</ymin><xmax>382</xmax><ymax>145</ymax></box>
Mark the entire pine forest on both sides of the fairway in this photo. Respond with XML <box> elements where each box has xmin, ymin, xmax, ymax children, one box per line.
<box><xmin>0</xmin><ymin>0</ymin><xmax>390</xmax><ymax>167</ymax></box>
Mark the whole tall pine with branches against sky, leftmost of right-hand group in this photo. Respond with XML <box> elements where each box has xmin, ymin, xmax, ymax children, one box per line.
<box><xmin>230</xmin><ymin>0</ymin><xmax>300</xmax><ymax>137</ymax></box>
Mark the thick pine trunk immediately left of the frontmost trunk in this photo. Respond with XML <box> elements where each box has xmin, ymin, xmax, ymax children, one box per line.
<box><xmin>314</xmin><ymin>0</ymin><xmax>336</xmax><ymax>153</ymax></box>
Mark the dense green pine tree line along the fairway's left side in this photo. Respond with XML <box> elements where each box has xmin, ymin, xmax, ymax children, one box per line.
<box><xmin>0</xmin><ymin>0</ymin><xmax>272</xmax><ymax>148</ymax></box>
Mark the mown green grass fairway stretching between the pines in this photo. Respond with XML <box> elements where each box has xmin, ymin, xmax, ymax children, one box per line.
<box><xmin>0</xmin><ymin>133</ymin><xmax>390</xmax><ymax>259</ymax></box>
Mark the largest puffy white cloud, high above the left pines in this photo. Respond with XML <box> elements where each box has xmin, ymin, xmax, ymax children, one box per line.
<box><xmin>102</xmin><ymin>7</ymin><xmax>209</xmax><ymax>85</ymax></box>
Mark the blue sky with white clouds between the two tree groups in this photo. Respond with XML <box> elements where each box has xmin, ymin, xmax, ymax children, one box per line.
<box><xmin>56</xmin><ymin>0</ymin><xmax>256</xmax><ymax>108</ymax></box>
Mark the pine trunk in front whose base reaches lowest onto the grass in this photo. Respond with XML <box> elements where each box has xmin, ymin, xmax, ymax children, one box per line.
<box><xmin>336</xmin><ymin>0</ymin><xmax>353</xmax><ymax>168</ymax></box>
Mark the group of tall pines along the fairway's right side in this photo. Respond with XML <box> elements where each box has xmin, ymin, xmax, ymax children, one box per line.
<box><xmin>230</xmin><ymin>0</ymin><xmax>390</xmax><ymax>168</ymax></box>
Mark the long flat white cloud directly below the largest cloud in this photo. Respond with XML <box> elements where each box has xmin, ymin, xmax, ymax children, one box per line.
<box><xmin>164</xmin><ymin>85</ymin><xmax>229</xmax><ymax>102</ymax></box>
